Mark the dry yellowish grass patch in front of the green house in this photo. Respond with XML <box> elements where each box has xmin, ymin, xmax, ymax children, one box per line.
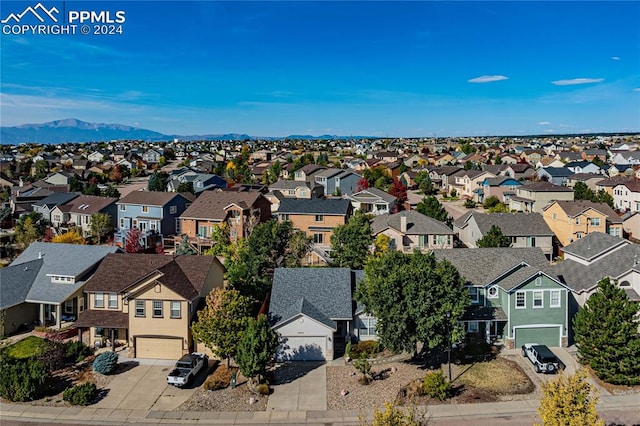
<box><xmin>454</xmin><ymin>358</ymin><xmax>535</xmax><ymax>395</ymax></box>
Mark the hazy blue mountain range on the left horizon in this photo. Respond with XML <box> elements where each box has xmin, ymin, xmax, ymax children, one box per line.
<box><xmin>0</xmin><ymin>118</ymin><xmax>368</xmax><ymax>145</ymax></box>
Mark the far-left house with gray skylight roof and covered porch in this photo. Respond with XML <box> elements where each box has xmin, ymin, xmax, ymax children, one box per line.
<box><xmin>0</xmin><ymin>242</ymin><xmax>119</xmax><ymax>334</ymax></box>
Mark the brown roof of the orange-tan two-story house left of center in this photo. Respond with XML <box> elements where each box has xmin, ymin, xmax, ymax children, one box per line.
<box><xmin>180</xmin><ymin>191</ymin><xmax>262</xmax><ymax>221</ymax></box>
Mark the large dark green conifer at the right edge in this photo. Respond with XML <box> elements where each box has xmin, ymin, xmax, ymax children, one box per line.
<box><xmin>573</xmin><ymin>277</ymin><xmax>640</xmax><ymax>385</ymax></box>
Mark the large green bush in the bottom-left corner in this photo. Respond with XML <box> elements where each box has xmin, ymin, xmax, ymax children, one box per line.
<box><xmin>0</xmin><ymin>354</ymin><xmax>50</xmax><ymax>402</ymax></box>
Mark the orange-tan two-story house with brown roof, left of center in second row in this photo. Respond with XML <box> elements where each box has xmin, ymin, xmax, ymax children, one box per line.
<box><xmin>180</xmin><ymin>191</ymin><xmax>271</xmax><ymax>251</ymax></box>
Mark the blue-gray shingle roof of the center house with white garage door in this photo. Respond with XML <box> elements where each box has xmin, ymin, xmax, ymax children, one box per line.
<box><xmin>269</xmin><ymin>268</ymin><xmax>358</xmax><ymax>328</ymax></box>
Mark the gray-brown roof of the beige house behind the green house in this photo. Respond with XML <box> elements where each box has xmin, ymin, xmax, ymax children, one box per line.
<box><xmin>453</xmin><ymin>211</ymin><xmax>553</xmax><ymax>237</ymax></box>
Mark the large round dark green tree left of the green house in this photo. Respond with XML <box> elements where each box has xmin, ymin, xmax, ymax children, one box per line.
<box><xmin>355</xmin><ymin>250</ymin><xmax>470</xmax><ymax>352</ymax></box>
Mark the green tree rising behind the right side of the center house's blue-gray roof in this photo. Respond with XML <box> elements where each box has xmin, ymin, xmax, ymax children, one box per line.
<box><xmin>331</xmin><ymin>210</ymin><xmax>373</xmax><ymax>269</ymax></box>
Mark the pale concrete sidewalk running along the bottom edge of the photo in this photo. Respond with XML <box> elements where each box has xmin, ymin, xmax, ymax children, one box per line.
<box><xmin>0</xmin><ymin>394</ymin><xmax>640</xmax><ymax>425</ymax></box>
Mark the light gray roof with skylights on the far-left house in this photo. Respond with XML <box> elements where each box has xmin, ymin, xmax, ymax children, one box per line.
<box><xmin>11</xmin><ymin>242</ymin><xmax>119</xmax><ymax>304</ymax></box>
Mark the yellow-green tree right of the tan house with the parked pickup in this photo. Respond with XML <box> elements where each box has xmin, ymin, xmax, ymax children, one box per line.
<box><xmin>191</xmin><ymin>288</ymin><xmax>251</xmax><ymax>367</ymax></box>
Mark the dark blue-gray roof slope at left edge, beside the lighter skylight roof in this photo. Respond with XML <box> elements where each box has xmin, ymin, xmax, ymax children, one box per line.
<box><xmin>0</xmin><ymin>259</ymin><xmax>43</xmax><ymax>309</ymax></box>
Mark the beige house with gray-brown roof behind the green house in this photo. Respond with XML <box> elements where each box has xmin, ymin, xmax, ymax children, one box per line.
<box><xmin>453</xmin><ymin>210</ymin><xmax>553</xmax><ymax>259</ymax></box>
